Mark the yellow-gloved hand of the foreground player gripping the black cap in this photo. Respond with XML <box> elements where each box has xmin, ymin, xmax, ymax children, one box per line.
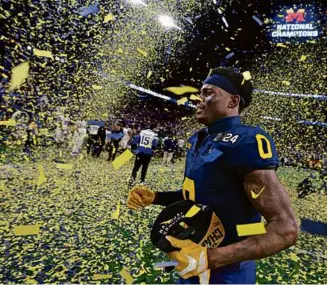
<box><xmin>166</xmin><ymin>236</ymin><xmax>210</xmax><ymax>284</ymax></box>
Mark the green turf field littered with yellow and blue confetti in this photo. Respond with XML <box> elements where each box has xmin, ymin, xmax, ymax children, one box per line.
<box><xmin>0</xmin><ymin>150</ymin><xmax>327</xmax><ymax>284</ymax></box>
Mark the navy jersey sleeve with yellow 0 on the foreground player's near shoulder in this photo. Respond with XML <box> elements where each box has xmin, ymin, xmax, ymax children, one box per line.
<box><xmin>229</xmin><ymin>128</ymin><xmax>279</xmax><ymax>175</ymax></box>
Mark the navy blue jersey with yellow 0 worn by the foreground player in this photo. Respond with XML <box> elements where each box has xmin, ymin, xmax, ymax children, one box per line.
<box><xmin>182</xmin><ymin>116</ymin><xmax>279</xmax><ymax>283</ymax></box>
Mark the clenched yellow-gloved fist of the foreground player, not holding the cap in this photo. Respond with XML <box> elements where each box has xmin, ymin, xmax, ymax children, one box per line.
<box><xmin>126</xmin><ymin>185</ymin><xmax>155</xmax><ymax>210</ymax></box>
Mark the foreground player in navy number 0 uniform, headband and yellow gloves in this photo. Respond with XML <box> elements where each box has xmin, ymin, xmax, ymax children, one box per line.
<box><xmin>127</xmin><ymin>68</ymin><xmax>299</xmax><ymax>284</ymax></box>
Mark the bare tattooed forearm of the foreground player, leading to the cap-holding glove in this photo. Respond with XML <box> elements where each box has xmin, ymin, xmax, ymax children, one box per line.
<box><xmin>208</xmin><ymin>221</ymin><xmax>298</xmax><ymax>269</ymax></box>
